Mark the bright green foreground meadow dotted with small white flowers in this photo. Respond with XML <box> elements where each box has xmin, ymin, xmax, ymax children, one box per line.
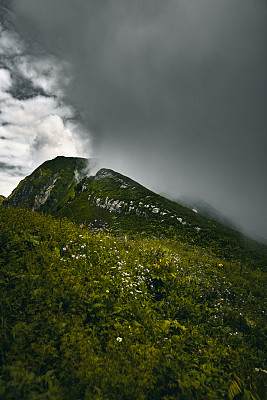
<box><xmin>0</xmin><ymin>206</ymin><xmax>267</xmax><ymax>400</ymax></box>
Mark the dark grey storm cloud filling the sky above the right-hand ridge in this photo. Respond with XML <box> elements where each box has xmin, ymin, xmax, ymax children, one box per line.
<box><xmin>10</xmin><ymin>0</ymin><xmax>267</xmax><ymax>237</ymax></box>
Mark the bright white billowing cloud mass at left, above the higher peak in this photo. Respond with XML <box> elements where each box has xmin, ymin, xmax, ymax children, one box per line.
<box><xmin>0</xmin><ymin>22</ymin><xmax>91</xmax><ymax>195</ymax></box>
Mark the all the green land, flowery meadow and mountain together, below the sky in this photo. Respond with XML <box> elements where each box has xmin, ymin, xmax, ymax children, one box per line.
<box><xmin>0</xmin><ymin>157</ymin><xmax>267</xmax><ymax>400</ymax></box>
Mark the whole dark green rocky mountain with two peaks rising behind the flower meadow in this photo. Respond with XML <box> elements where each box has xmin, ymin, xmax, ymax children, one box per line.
<box><xmin>3</xmin><ymin>157</ymin><xmax>266</xmax><ymax>265</ymax></box>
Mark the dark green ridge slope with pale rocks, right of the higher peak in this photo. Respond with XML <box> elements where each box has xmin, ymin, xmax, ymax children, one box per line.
<box><xmin>57</xmin><ymin>170</ymin><xmax>267</xmax><ymax>266</ymax></box>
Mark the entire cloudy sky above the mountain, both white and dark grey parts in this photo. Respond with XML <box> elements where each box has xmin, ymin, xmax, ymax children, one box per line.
<box><xmin>0</xmin><ymin>0</ymin><xmax>267</xmax><ymax>238</ymax></box>
